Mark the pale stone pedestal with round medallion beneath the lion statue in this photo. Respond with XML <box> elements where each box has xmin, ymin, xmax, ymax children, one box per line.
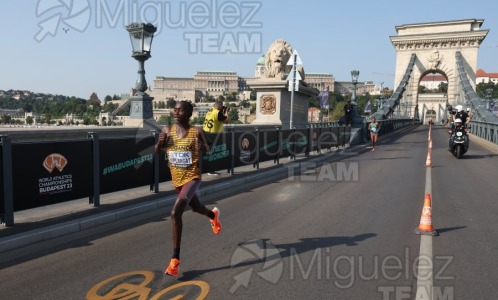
<box><xmin>251</xmin><ymin>78</ymin><xmax>318</xmax><ymax>129</ymax></box>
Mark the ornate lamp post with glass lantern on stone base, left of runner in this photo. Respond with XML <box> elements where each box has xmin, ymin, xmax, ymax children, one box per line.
<box><xmin>126</xmin><ymin>23</ymin><xmax>157</xmax><ymax>126</ymax></box>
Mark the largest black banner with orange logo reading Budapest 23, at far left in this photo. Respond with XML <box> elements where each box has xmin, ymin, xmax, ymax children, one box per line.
<box><xmin>12</xmin><ymin>140</ymin><xmax>92</xmax><ymax>211</ymax></box>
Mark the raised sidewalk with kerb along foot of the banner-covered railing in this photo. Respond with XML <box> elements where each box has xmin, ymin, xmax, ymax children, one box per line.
<box><xmin>0</xmin><ymin>139</ymin><xmax>368</xmax><ymax>253</ymax></box>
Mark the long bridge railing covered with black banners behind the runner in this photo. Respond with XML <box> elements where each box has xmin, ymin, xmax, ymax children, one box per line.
<box><xmin>0</xmin><ymin>123</ymin><xmax>351</xmax><ymax>226</ymax></box>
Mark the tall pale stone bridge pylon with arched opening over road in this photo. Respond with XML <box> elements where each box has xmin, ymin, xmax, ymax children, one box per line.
<box><xmin>390</xmin><ymin>19</ymin><xmax>489</xmax><ymax>121</ymax></box>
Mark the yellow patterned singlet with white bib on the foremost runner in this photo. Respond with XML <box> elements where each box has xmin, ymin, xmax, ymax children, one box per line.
<box><xmin>166</xmin><ymin>124</ymin><xmax>201</xmax><ymax>187</ymax></box>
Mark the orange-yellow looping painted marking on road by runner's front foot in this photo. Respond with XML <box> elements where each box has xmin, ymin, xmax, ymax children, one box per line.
<box><xmin>86</xmin><ymin>270</ymin><xmax>209</xmax><ymax>300</ymax></box>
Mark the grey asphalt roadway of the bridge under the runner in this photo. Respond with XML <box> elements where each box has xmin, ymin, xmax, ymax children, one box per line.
<box><xmin>0</xmin><ymin>126</ymin><xmax>498</xmax><ymax>299</ymax></box>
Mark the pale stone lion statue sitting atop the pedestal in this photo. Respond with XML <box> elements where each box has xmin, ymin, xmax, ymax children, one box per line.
<box><xmin>264</xmin><ymin>39</ymin><xmax>304</xmax><ymax>80</ymax></box>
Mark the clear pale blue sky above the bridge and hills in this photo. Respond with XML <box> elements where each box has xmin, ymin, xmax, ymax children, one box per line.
<box><xmin>0</xmin><ymin>0</ymin><xmax>498</xmax><ymax>99</ymax></box>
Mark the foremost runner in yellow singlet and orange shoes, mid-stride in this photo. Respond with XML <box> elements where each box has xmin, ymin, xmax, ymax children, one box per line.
<box><xmin>155</xmin><ymin>101</ymin><xmax>221</xmax><ymax>276</ymax></box>
